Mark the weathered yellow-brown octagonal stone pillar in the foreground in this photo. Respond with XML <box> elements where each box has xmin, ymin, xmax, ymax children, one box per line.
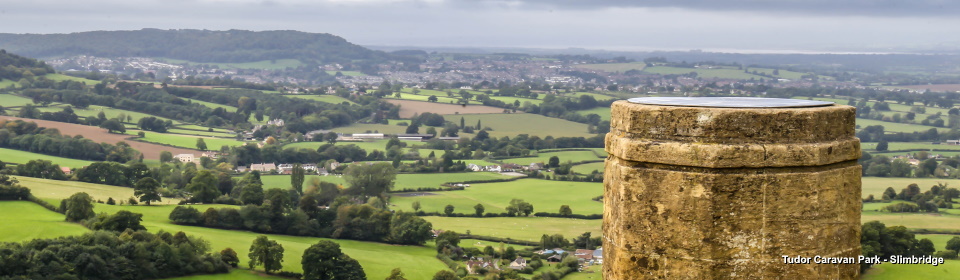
<box><xmin>603</xmin><ymin>98</ymin><xmax>861</xmax><ymax>280</ymax></box>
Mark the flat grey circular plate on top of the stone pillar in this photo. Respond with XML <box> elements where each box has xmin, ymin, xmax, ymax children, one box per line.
<box><xmin>627</xmin><ymin>97</ymin><xmax>834</xmax><ymax>108</ymax></box>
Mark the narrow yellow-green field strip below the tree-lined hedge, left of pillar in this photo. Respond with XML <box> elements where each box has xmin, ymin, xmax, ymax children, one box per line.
<box><xmin>423</xmin><ymin>217</ymin><xmax>603</xmax><ymax>241</ymax></box>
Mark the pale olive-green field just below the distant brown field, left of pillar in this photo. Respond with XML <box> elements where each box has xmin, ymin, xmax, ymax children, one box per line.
<box><xmin>447</xmin><ymin>114</ymin><xmax>593</xmax><ymax>138</ymax></box>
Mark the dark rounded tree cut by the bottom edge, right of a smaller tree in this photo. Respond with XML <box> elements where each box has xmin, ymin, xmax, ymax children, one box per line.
<box><xmin>300</xmin><ymin>240</ymin><xmax>366</xmax><ymax>280</ymax></box>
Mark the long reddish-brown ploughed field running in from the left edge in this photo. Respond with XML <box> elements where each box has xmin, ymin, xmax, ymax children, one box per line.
<box><xmin>0</xmin><ymin>116</ymin><xmax>197</xmax><ymax>159</ymax></box>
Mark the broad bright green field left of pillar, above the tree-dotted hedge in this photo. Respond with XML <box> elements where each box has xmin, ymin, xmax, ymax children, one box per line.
<box><xmin>390</xmin><ymin>178</ymin><xmax>603</xmax><ymax>214</ymax></box>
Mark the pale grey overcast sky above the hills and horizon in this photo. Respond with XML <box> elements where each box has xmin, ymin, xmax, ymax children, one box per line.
<box><xmin>0</xmin><ymin>0</ymin><xmax>960</xmax><ymax>51</ymax></box>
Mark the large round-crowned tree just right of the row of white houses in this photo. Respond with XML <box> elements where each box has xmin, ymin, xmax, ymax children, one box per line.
<box><xmin>344</xmin><ymin>162</ymin><xmax>397</xmax><ymax>196</ymax></box>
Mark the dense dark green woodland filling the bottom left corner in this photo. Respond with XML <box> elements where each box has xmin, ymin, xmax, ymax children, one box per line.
<box><xmin>0</xmin><ymin>231</ymin><xmax>229</xmax><ymax>279</ymax></box>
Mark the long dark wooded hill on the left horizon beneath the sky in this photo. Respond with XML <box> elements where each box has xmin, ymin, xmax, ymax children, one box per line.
<box><xmin>0</xmin><ymin>29</ymin><xmax>401</xmax><ymax>63</ymax></box>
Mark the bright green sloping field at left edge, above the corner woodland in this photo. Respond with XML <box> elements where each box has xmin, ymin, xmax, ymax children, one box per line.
<box><xmin>0</xmin><ymin>201</ymin><xmax>87</xmax><ymax>242</ymax></box>
